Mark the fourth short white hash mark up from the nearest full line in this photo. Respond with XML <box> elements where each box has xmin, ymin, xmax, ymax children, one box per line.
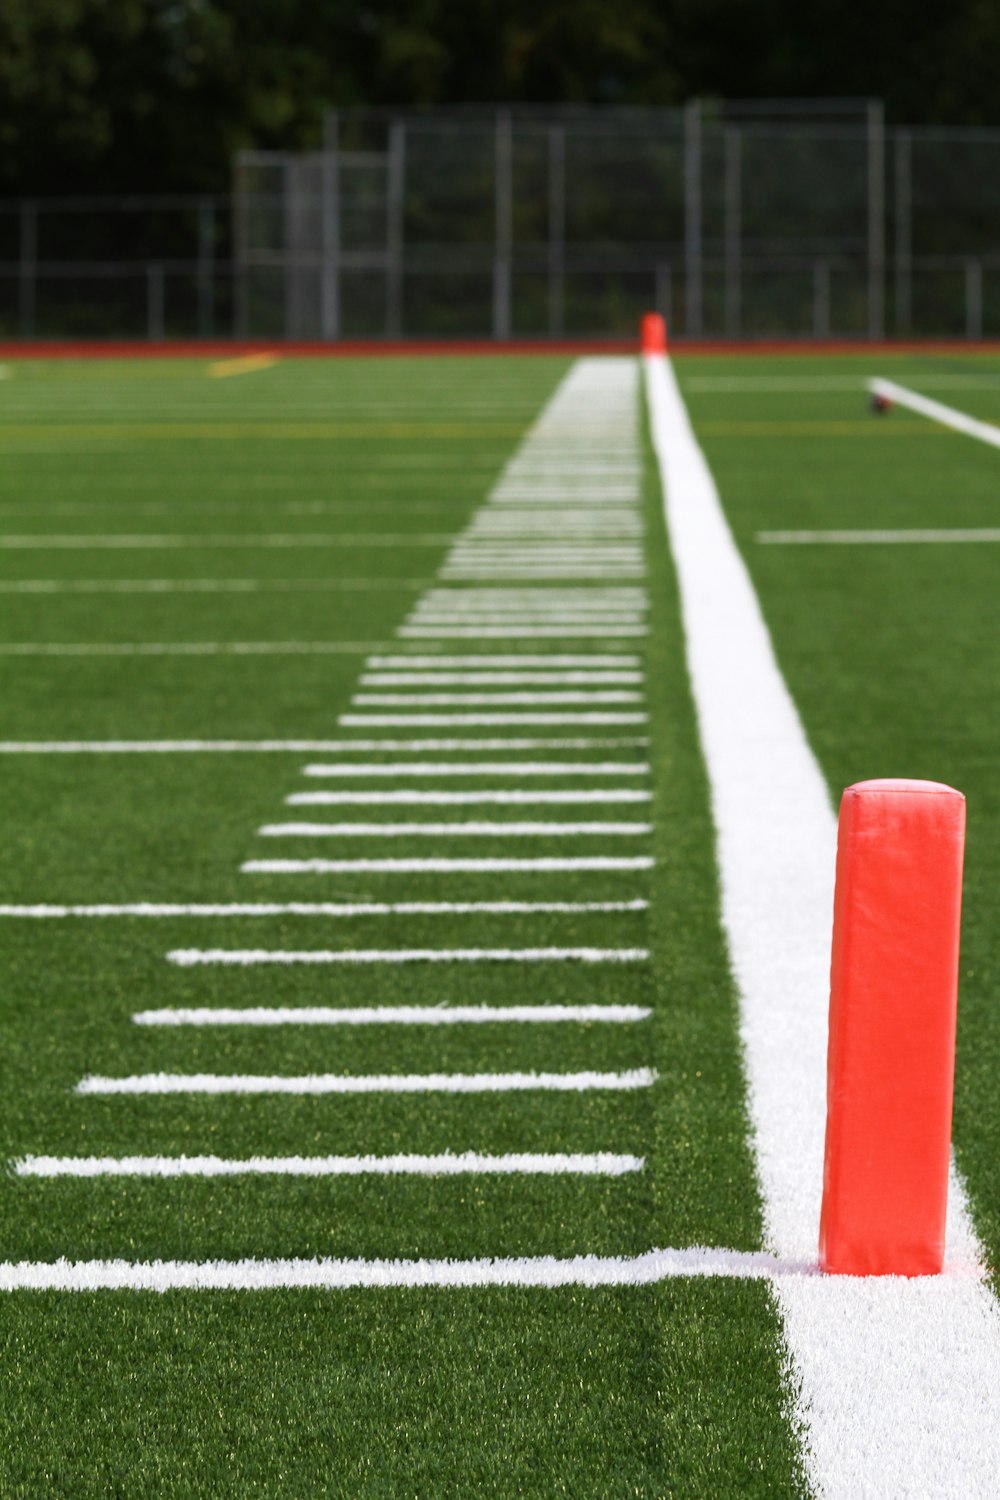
<box><xmin>166</xmin><ymin>948</ymin><xmax>649</xmax><ymax>969</ymax></box>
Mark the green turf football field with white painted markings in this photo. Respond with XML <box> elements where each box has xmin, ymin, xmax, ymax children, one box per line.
<box><xmin>0</xmin><ymin>350</ymin><xmax>1000</xmax><ymax>1497</ymax></box>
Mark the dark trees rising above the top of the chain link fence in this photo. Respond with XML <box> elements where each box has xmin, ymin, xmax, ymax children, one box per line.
<box><xmin>0</xmin><ymin>0</ymin><xmax>1000</xmax><ymax>195</ymax></box>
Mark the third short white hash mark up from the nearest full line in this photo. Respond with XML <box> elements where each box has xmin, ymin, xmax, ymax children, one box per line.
<box><xmin>132</xmin><ymin>1005</ymin><xmax>652</xmax><ymax>1026</ymax></box>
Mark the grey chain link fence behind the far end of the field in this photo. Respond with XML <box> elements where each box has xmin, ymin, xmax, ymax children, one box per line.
<box><xmin>0</xmin><ymin>101</ymin><xmax>1000</xmax><ymax>342</ymax></box>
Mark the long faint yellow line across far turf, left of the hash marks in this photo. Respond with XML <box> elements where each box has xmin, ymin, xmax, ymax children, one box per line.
<box><xmin>0</xmin><ymin>422</ymin><xmax>525</xmax><ymax>441</ymax></box>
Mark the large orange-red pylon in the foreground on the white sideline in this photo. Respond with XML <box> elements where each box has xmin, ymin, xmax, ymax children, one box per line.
<box><xmin>820</xmin><ymin>780</ymin><xmax>966</xmax><ymax>1277</ymax></box>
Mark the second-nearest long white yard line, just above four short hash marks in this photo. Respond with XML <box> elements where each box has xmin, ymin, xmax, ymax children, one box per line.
<box><xmin>0</xmin><ymin>899</ymin><xmax>649</xmax><ymax>920</ymax></box>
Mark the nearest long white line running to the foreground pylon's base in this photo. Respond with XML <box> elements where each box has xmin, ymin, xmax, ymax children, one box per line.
<box><xmin>0</xmin><ymin>1245</ymin><xmax>827</xmax><ymax>1296</ymax></box>
